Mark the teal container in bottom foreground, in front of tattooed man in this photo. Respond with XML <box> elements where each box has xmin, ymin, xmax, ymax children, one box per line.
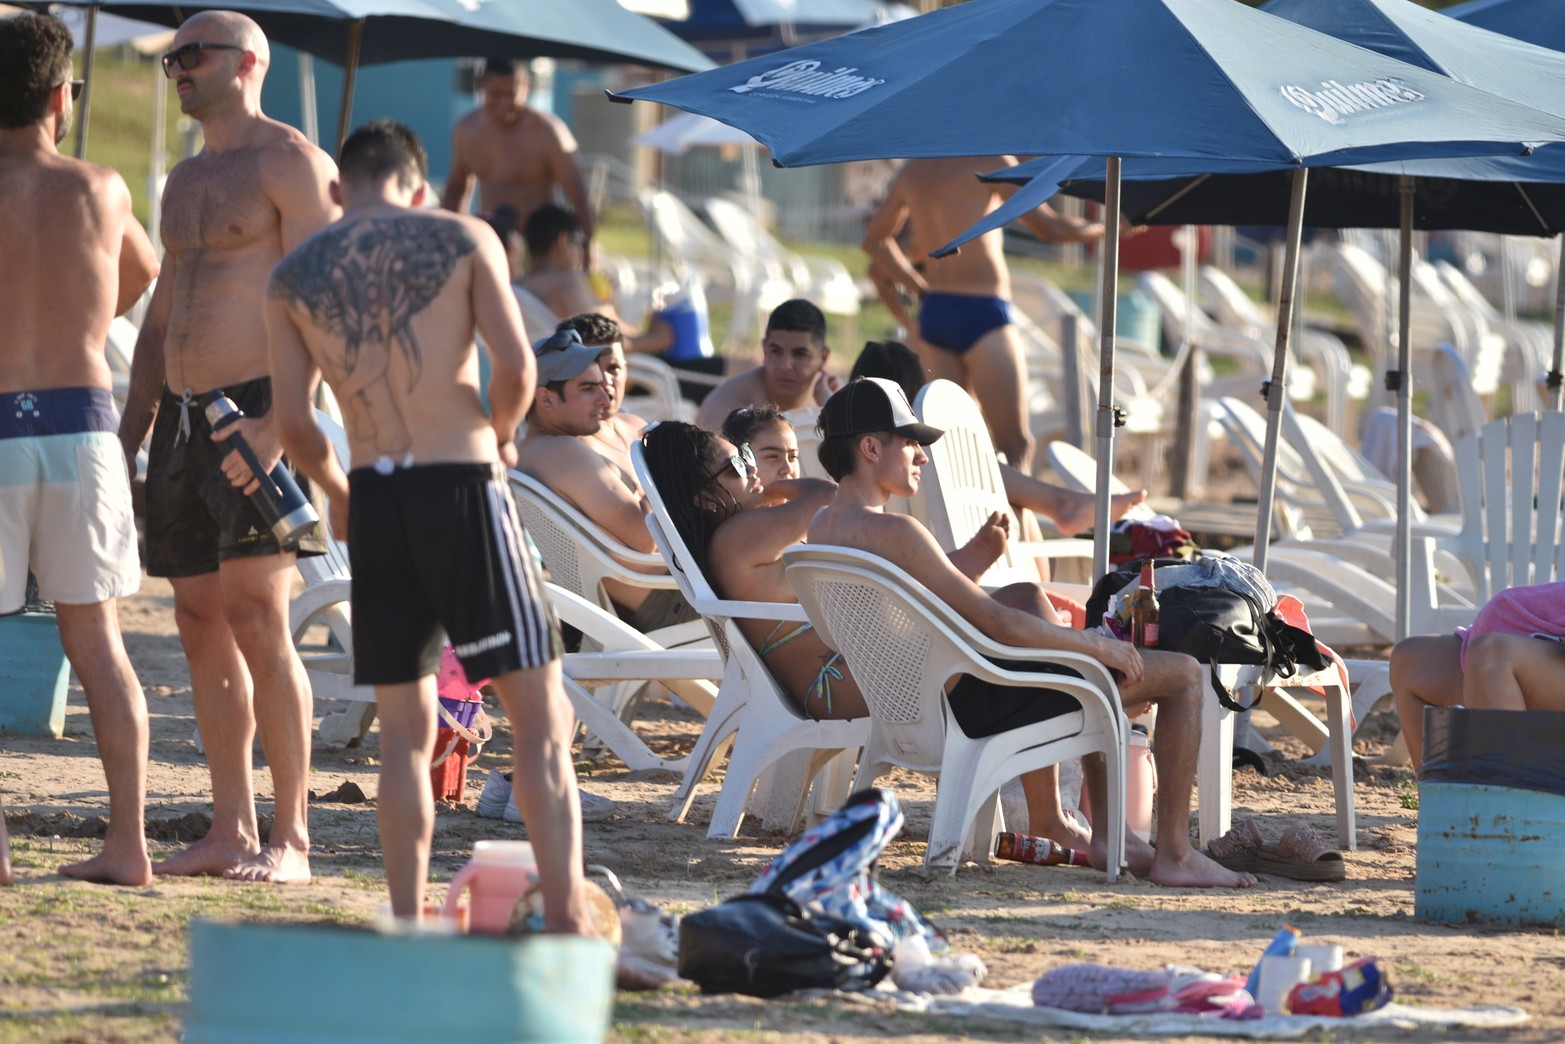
<box><xmin>185</xmin><ymin>920</ymin><xmax>615</xmax><ymax>1044</ymax></box>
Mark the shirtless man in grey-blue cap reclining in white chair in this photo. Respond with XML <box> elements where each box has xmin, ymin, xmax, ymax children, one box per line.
<box><xmin>516</xmin><ymin>329</ymin><xmax>696</xmax><ymax>632</ymax></box>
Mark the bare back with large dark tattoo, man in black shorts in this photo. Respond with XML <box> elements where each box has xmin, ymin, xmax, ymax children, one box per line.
<box><xmin>269</xmin><ymin>208</ymin><xmax>495</xmax><ymax>468</ymax></box>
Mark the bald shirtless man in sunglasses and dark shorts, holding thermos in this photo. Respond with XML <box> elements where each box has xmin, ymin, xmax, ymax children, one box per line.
<box><xmin>119</xmin><ymin>11</ymin><xmax>336</xmax><ymax>884</ymax></box>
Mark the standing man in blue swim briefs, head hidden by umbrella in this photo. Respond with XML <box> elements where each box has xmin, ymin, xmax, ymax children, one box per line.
<box><xmin>864</xmin><ymin>157</ymin><xmax>1103</xmax><ymax>474</ymax></box>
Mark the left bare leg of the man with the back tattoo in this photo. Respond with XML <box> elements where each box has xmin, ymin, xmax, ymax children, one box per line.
<box><xmin>376</xmin><ymin>676</ymin><xmax>435</xmax><ymax>919</ymax></box>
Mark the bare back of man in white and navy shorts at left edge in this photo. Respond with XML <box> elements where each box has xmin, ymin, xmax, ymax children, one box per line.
<box><xmin>0</xmin><ymin>150</ymin><xmax>157</xmax><ymax>391</ymax></box>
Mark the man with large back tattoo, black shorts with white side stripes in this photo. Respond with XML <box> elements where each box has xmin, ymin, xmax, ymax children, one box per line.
<box><xmin>266</xmin><ymin>121</ymin><xmax>593</xmax><ymax>934</ymax></box>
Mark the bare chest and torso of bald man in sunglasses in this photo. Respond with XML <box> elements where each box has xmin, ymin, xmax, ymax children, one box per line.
<box><xmin>163</xmin><ymin>117</ymin><xmax>333</xmax><ymax>391</ymax></box>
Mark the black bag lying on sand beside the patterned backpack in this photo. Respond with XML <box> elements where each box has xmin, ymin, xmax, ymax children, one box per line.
<box><xmin>679</xmin><ymin>895</ymin><xmax>890</xmax><ymax>997</ymax></box>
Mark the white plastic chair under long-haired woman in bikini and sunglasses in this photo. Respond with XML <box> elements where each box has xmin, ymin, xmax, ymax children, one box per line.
<box><xmin>631</xmin><ymin>443</ymin><xmax>870</xmax><ymax>837</ymax></box>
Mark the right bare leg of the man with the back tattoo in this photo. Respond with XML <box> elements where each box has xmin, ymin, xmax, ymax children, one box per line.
<box><xmin>495</xmin><ymin>661</ymin><xmax>598</xmax><ymax>936</ymax></box>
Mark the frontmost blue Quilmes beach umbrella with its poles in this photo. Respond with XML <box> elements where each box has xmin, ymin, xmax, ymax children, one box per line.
<box><xmin>610</xmin><ymin>0</ymin><xmax>1562</xmax><ymax>571</ymax></box>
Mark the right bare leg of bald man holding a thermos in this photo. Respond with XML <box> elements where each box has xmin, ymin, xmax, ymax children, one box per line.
<box><xmin>218</xmin><ymin>554</ymin><xmax>311</xmax><ymax>884</ymax></box>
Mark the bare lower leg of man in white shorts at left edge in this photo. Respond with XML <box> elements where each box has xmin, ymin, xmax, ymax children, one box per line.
<box><xmin>55</xmin><ymin>599</ymin><xmax>152</xmax><ymax>884</ymax></box>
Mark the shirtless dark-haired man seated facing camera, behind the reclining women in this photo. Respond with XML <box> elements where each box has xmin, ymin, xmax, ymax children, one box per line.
<box><xmin>698</xmin><ymin>299</ymin><xmax>842</xmax><ymax>432</ymax></box>
